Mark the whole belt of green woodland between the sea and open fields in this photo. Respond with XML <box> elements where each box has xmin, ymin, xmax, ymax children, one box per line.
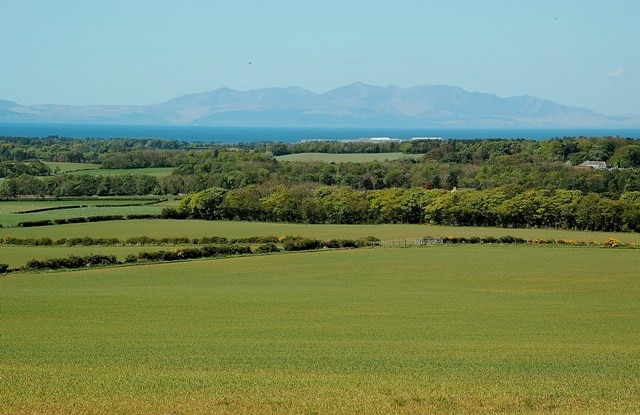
<box><xmin>0</xmin><ymin>137</ymin><xmax>640</xmax><ymax>231</ymax></box>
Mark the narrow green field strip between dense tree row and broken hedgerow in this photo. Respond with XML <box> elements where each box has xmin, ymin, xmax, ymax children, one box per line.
<box><xmin>0</xmin><ymin>219</ymin><xmax>640</xmax><ymax>244</ymax></box>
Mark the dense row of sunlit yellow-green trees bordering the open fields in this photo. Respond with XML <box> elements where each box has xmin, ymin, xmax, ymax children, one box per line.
<box><xmin>171</xmin><ymin>184</ymin><xmax>640</xmax><ymax>232</ymax></box>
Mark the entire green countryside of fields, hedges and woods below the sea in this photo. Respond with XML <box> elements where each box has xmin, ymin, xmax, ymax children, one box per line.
<box><xmin>0</xmin><ymin>137</ymin><xmax>640</xmax><ymax>414</ymax></box>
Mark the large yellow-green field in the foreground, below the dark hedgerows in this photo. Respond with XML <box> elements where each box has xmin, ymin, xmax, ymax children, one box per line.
<box><xmin>0</xmin><ymin>246</ymin><xmax>640</xmax><ymax>414</ymax></box>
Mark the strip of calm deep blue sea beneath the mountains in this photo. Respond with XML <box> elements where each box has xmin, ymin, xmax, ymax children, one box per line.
<box><xmin>0</xmin><ymin>123</ymin><xmax>640</xmax><ymax>144</ymax></box>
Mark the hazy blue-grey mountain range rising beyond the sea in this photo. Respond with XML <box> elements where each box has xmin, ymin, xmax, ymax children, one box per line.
<box><xmin>0</xmin><ymin>83</ymin><xmax>640</xmax><ymax>128</ymax></box>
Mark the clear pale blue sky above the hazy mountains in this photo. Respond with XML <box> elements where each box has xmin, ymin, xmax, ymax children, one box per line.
<box><xmin>0</xmin><ymin>0</ymin><xmax>640</xmax><ymax>115</ymax></box>
